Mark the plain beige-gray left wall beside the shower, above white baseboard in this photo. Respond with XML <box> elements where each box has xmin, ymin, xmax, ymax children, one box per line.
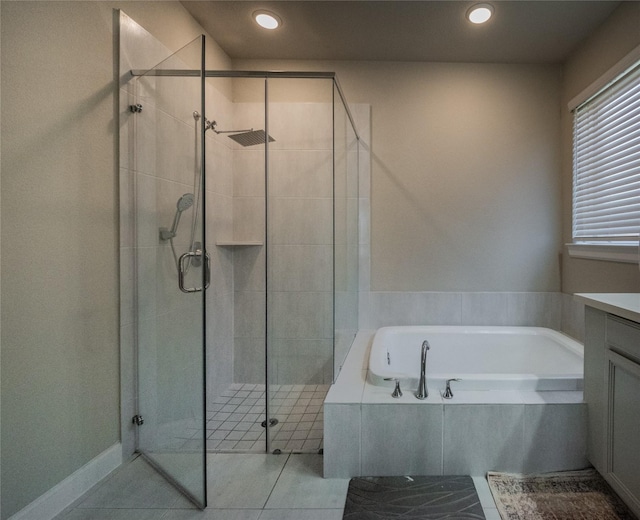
<box><xmin>0</xmin><ymin>1</ymin><xmax>228</xmax><ymax>518</ymax></box>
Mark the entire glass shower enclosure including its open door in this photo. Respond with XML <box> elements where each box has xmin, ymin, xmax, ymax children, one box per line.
<box><xmin>122</xmin><ymin>30</ymin><xmax>359</xmax><ymax>506</ymax></box>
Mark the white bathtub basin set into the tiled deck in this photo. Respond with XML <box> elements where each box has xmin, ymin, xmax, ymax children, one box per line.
<box><xmin>367</xmin><ymin>326</ymin><xmax>583</xmax><ymax>392</ymax></box>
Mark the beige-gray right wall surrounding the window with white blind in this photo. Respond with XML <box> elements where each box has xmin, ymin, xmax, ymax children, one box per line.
<box><xmin>560</xmin><ymin>2</ymin><xmax>640</xmax><ymax>293</ymax></box>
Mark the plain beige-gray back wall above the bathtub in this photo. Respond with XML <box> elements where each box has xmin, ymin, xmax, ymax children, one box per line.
<box><xmin>234</xmin><ymin>60</ymin><xmax>561</xmax><ymax>292</ymax></box>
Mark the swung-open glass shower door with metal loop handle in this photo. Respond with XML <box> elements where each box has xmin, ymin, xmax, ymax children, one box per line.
<box><xmin>135</xmin><ymin>34</ymin><xmax>206</xmax><ymax>507</ymax></box>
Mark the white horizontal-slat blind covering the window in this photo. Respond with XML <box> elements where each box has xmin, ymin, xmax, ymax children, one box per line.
<box><xmin>573</xmin><ymin>62</ymin><xmax>640</xmax><ymax>244</ymax></box>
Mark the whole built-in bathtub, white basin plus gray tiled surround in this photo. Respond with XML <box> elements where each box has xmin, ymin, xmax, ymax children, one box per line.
<box><xmin>323</xmin><ymin>326</ymin><xmax>589</xmax><ymax>478</ymax></box>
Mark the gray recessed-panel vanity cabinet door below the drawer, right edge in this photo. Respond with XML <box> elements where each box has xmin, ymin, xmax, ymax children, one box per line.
<box><xmin>608</xmin><ymin>351</ymin><xmax>640</xmax><ymax>514</ymax></box>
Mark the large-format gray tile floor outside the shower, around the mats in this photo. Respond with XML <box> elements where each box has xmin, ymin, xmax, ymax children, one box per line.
<box><xmin>56</xmin><ymin>453</ymin><xmax>500</xmax><ymax>520</ymax></box>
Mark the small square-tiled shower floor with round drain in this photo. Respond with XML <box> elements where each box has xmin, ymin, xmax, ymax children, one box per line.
<box><xmin>207</xmin><ymin>384</ymin><xmax>329</xmax><ymax>453</ymax></box>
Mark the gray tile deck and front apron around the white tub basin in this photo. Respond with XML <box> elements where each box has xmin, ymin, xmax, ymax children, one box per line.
<box><xmin>324</xmin><ymin>330</ymin><xmax>588</xmax><ymax>478</ymax></box>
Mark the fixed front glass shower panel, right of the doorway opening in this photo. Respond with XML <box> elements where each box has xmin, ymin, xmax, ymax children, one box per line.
<box><xmin>267</xmin><ymin>78</ymin><xmax>334</xmax><ymax>452</ymax></box>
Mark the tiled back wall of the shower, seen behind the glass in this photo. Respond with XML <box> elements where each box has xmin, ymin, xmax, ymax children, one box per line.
<box><xmin>233</xmin><ymin>103</ymin><xmax>340</xmax><ymax>384</ymax></box>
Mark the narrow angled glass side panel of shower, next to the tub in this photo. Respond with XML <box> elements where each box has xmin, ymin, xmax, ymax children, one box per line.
<box><xmin>334</xmin><ymin>85</ymin><xmax>359</xmax><ymax>380</ymax></box>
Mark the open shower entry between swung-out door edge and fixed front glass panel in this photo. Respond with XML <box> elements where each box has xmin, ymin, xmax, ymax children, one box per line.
<box><xmin>205</xmin><ymin>78</ymin><xmax>266</xmax><ymax>453</ymax></box>
